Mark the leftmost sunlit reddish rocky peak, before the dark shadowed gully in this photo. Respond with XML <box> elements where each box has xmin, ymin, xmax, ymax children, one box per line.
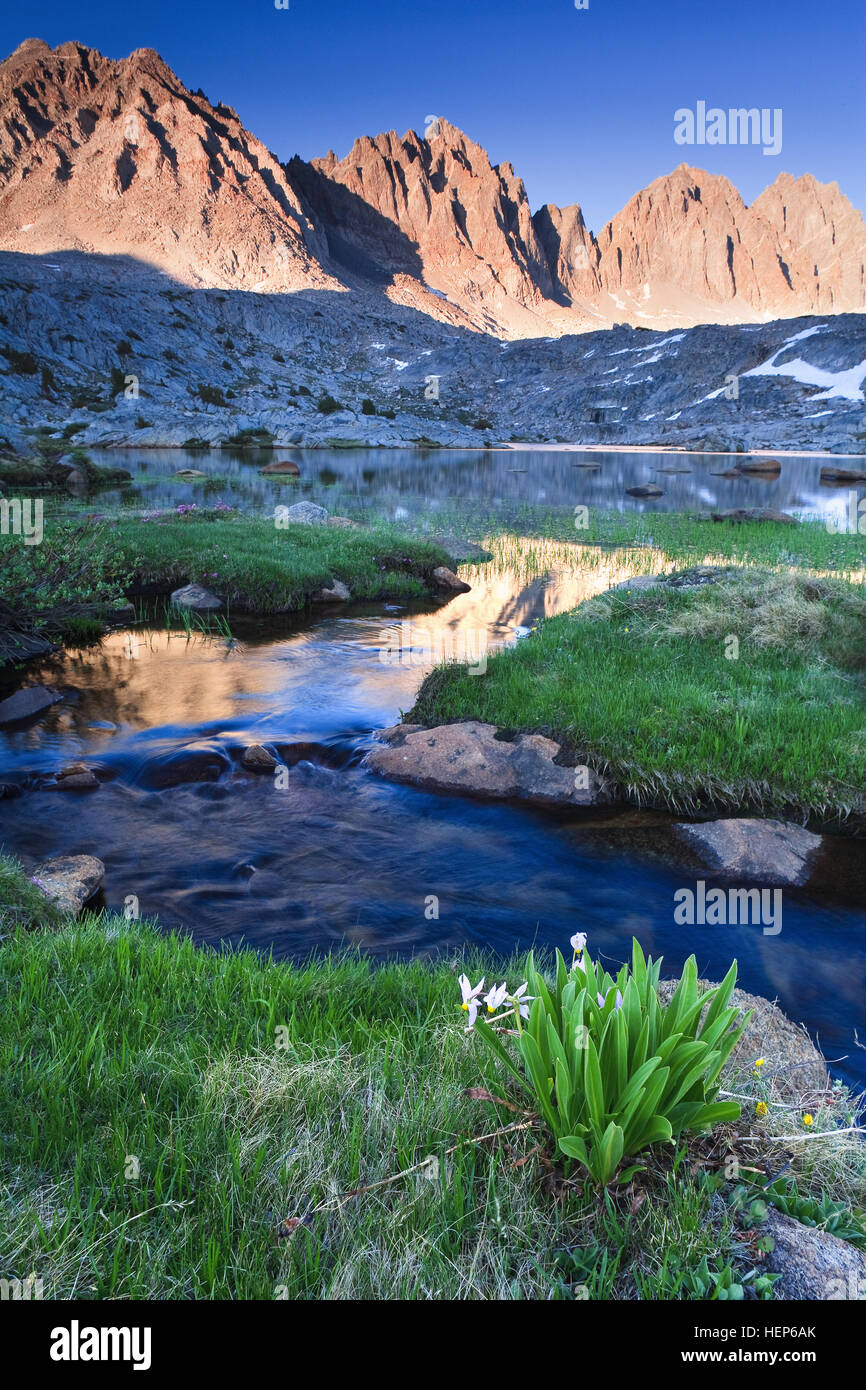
<box><xmin>0</xmin><ymin>40</ymin><xmax>332</xmax><ymax>289</ymax></box>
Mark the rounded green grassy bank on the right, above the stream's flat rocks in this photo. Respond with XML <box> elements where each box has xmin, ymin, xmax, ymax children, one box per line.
<box><xmin>407</xmin><ymin>570</ymin><xmax>866</xmax><ymax>819</ymax></box>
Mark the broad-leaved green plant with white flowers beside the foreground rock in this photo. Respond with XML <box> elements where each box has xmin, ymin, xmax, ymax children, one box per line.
<box><xmin>461</xmin><ymin>934</ymin><xmax>746</xmax><ymax>1186</ymax></box>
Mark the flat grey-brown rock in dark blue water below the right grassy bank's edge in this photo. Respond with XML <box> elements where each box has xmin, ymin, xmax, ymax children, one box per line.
<box><xmin>673</xmin><ymin>820</ymin><xmax>822</xmax><ymax>888</ymax></box>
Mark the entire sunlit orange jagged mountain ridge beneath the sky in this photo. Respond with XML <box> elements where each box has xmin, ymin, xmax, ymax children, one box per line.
<box><xmin>0</xmin><ymin>39</ymin><xmax>866</xmax><ymax>338</ymax></box>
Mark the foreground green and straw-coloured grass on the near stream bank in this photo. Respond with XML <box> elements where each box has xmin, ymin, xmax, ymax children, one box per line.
<box><xmin>0</xmin><ymin>859</ymin><xmax>863</xmax><ymax>1300</ymax></box>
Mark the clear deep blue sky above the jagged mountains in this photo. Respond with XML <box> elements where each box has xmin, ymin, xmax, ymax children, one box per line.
<box><xmin>0</xmin><ymin>0</ymin><xmax>866</xmax><ymax>231</ymax></box>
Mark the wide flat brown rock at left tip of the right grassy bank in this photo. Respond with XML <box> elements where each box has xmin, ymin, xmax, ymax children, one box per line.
<box><xmin>364</xmin><ymin>720</ymin><xmax>605</xmax><ymax>806</ymax></box>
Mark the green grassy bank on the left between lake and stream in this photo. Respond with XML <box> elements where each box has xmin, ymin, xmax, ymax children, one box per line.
<box><xmin>0</xmin><ymin>509</ymin><xmax>458</xmax><ymax>664</ymax></box>
